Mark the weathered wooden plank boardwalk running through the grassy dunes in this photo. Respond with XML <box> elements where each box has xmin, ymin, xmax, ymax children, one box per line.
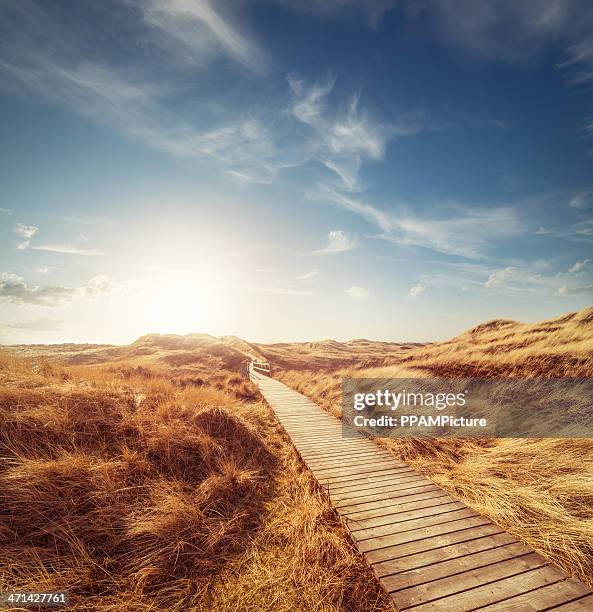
<box><xmin>250</xmin><ymin>366</ymin><xmax>593</xmax><ymax>612</ymax></box>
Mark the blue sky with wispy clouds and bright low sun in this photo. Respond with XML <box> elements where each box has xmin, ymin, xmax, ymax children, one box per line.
<box><xmin>0</xmin><ymin>0</ymin><xmax>593</xmax><ymax>344</ymax></box>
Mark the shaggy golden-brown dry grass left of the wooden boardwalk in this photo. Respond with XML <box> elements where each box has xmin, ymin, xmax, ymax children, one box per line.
<box><xmin>0</xmin><ymin>354</ymin><xmax>390</xmax><ymax>612</ymax></box>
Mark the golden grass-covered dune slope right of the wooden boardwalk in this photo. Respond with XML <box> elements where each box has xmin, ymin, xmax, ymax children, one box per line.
<box><xmin>278</xmin><ymin>308</ymin><xmax>593</xmax><ymax>586</ymax></box>
